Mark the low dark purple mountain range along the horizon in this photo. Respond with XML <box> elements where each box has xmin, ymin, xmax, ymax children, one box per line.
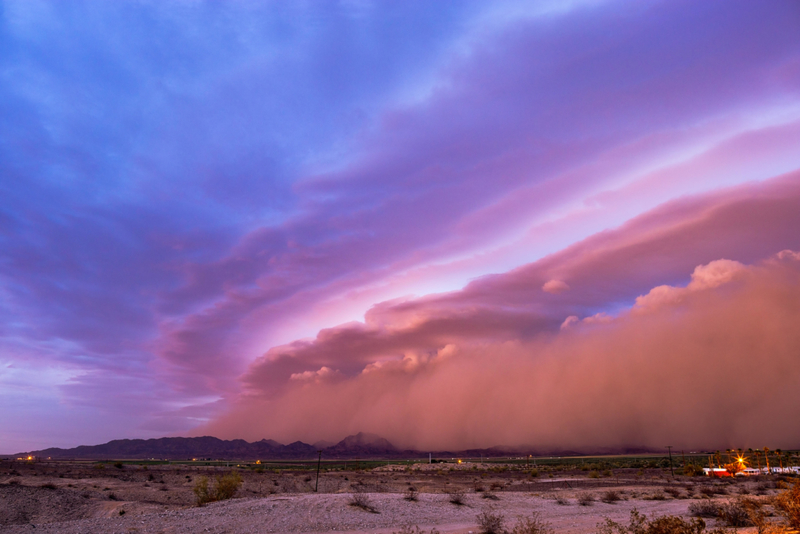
<box><xmin>18</xmin><ymin>432</ymin><xmax>664</xmax><ymax>460</ymax></box>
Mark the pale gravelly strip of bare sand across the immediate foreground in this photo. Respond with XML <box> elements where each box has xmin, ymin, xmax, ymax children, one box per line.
<box><xmin>3</xmin><ymin>493</ymin><xmax>724</xmax><ymax>534</ymax></box>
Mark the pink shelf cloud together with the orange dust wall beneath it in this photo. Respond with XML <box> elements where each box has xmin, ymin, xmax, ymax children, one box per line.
<box><xmin>199</xmin><ymin>173</ymin><xmax>800</xmax><ymax>448</ymax></box>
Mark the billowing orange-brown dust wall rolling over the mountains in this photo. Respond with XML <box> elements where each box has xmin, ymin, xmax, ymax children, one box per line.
<box><xmin>198</xmin><ymin>255</ymin><xmax>800</xmax><ymax>449</ymax></box>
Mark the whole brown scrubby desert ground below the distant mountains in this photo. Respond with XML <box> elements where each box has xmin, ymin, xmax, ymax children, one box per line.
<box><xmin>0</xmin><ymin>461</ymin><xmax>791</xmax><ymax>534</ymax></box>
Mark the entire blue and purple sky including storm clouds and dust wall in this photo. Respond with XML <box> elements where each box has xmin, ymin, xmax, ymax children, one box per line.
<box><xmin>0</xmin><ymin>0</ymin><xmax>800</xmax><ymax>453</ymax></box>
